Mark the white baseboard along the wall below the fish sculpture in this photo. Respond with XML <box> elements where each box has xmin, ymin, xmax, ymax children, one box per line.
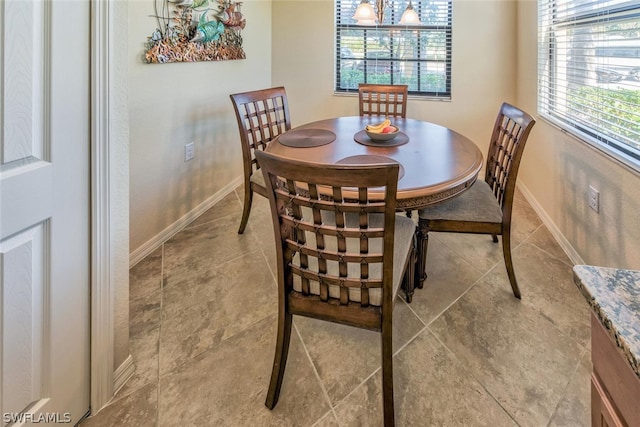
<box><xmin>129</xmin><ymin>176</ymin><xmax>244</xmax><ymax>268</ymax></box>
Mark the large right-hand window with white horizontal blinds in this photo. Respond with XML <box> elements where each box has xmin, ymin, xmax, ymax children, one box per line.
<box><xmin>538</xmin><ymin>0</ymin><xmax>640</xmax><ymax>169</ymax></box>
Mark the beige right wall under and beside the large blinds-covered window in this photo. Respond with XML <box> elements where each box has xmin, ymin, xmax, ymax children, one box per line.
<box><xmin>517</xmin><ymin>0</ymin><xmax>640</xmax><ymax>269</ymax></box>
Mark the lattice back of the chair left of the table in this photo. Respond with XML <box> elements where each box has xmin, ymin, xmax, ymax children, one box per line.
<box><xmin>230</xmin><ymin>87</ymin><xmax>291</xmax><ymax>175</ymax></box>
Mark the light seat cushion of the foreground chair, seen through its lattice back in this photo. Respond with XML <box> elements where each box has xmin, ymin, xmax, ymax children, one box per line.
<box><xmin>292</xmin><ymin>213</ymin><xmax>416</xmax><ymax>306</ymax></box>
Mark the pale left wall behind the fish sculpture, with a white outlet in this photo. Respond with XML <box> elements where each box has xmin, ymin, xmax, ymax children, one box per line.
<box><xmin>128</xmin><ymin>0</ymin><xmax>271</xmax><ymax>252</ymax></box>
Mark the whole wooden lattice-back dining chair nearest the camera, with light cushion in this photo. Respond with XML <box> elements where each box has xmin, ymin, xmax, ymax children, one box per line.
<box><xmin>256</xmin><ymin>152</ymin><xmax>415</xmax><ymax>426</ymax></box>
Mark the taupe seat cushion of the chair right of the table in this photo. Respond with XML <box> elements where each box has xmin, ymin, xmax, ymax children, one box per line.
<box><xmin>418</xmin><ymin>179</ymin><xmax>502</xmax><ymax>224</ymax></box>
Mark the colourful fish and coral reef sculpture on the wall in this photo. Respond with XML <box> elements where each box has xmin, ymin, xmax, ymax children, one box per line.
<box><xmin>145</xmin><ymin>0</ymin><xmax>246</xmax><ymax>64</ymax></box>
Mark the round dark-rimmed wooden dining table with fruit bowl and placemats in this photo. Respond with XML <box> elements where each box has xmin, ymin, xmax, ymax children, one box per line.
<box><xmin>266</xmin><ymin>116</ymin><xmax>482</xmax><ymax>211</ymax></box>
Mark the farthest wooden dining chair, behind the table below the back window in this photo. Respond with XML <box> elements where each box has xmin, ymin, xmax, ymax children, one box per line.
<box><xmin>358</xmin><ymin>83</ymin><xmax>408</xmax><ymax>118</ymax></box>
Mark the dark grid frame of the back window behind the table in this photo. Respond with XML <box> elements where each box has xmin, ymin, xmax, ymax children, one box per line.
<box><xmin>333</xmin><ymin>0</ymin><xmax>453</xmax><ymax>101</ymax></box>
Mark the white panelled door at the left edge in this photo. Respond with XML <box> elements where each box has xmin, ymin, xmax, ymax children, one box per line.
<box><xmin>0</xmin><ymin>0</ymin><xmax>90</xmax><ymax>425</ymax></box>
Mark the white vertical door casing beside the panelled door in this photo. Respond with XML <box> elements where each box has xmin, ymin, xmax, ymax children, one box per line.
<box><xmin>90</xmin><ymin>0</ymin><xmax>114</xmax><ymax>414</ymax></box>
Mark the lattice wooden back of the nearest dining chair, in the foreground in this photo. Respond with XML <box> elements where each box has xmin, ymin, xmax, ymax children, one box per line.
<box><xmin>258</xmin><ymin>152</ymin><xmax>402</xmax><ymax>321</ymax></box>
